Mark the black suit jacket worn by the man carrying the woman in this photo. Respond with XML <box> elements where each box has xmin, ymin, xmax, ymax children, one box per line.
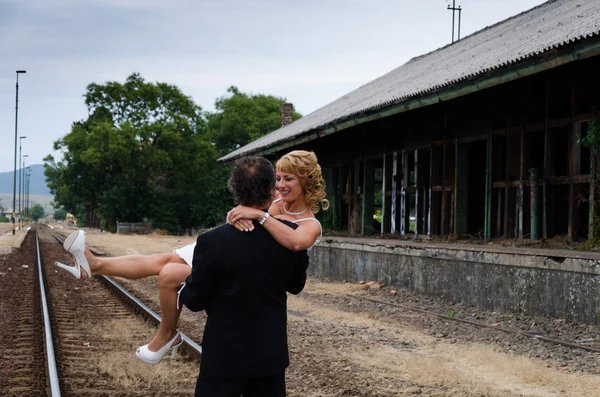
<box><xmin>180</xmin><ymin>221</ymin><xmax>308</xmax><ymax>379</ymax></box>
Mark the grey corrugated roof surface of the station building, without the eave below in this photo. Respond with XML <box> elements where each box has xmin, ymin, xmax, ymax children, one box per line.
<box><xmin>220</xmin><ymin>0</ymin><xmax>600</xmax><ymax>161</ymax></box>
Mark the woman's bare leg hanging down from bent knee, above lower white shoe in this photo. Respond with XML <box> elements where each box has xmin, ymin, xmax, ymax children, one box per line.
<box><xmin>148</xmin><ymin>263</ymin><xmax>192</xmax><ymax>351</ymax></box>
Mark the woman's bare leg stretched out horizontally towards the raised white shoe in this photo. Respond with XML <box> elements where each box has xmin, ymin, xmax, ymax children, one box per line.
<box><xmin>85</xmin><ymin>248</ymin><xmax>184</xmax><ymax>280</ymax></box>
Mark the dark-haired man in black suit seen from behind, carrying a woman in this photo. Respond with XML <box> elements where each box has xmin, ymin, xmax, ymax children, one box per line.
<box><xmin>180</xmin><ymin>157</ymin><xmax>308</xmax><ymax>397</ymax></box>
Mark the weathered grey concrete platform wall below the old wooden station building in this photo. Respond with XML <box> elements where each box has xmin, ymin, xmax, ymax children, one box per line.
<box><xmin>309</xmin><ymin>238</ymin><xmax>600</xmax><ymax>324</ymax></box>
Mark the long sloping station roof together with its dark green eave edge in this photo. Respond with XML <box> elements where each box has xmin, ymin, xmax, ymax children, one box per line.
<box><xmin>219</xmin><ymin>0</ymin><xmax>600</xmax><ymax>162</ymax></box>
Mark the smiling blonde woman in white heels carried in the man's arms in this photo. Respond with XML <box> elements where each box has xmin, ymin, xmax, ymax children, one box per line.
<box><xmin>56</xmin><ymin>150</ymin><xmax>329</xmax><ymax>364</ymax></box>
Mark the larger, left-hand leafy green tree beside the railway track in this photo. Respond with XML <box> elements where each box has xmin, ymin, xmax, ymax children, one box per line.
<box><xmin>45</xmin><ymin>74</ymin><xmax>209</xmax><ymax>231</ymax></box>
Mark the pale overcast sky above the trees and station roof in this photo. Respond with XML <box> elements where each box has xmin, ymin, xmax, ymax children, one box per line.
<box><xmin>0</xmin><ymin>0</ymin><xmax>543</xmax><ymax>172</ymax></box>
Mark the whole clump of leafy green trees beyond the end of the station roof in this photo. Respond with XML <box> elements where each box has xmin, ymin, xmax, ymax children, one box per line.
<box><xmin>44</xmin><ymin>74</ymin><xmax>300</xmax><ymax>233</ymax></box>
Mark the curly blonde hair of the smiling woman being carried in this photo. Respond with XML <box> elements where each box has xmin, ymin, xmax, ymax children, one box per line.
<box><xmin>275</xmin><ymin>150</ymin><xmax>329</xmax><ymax>214</ymax></box>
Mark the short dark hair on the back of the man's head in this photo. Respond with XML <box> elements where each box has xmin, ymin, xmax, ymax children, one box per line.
<box><xmin>227</xmin><ymin>157</ymin><xmax>275</xmax><ymax>207</ymax></box>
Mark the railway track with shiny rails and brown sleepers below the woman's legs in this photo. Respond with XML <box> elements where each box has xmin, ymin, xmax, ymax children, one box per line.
<box><xmin>0</xmin><ymin>228</ymin><xmax>201</xmax><ymax>397</ymax></box>
